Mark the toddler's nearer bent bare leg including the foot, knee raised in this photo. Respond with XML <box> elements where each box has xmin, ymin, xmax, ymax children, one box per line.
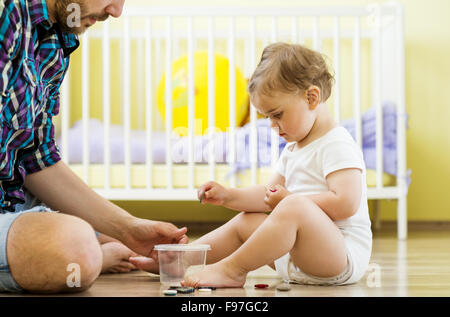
<box><xmin>182</xmin><ymin>195</ymin><xmax>347</xmax><ymax>287</ymax></box>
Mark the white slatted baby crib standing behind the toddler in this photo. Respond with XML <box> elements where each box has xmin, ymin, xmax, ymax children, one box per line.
<box><xmin>59</xmin><ymin>2</ymin><xmax>408</xmax><ymax>239</ymax></box>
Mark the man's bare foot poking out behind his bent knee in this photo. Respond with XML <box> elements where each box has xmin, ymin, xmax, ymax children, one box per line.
<box><xmin>101</xmin><ymin>242</ymin><xmax>137</xmax><ymax>273</ymax></box>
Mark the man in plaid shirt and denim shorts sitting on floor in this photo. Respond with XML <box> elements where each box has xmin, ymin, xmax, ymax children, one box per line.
<box><xmin>0</xmin><ymin>0</ymin><xmax>187</xmax><ymax>293</ymax></box>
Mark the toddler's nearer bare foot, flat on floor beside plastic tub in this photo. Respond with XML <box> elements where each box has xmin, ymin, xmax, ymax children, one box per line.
<box><xmin>181</xmin><ymin>261</ymin><xmax>247</xmax><ymax>287</ymax></box>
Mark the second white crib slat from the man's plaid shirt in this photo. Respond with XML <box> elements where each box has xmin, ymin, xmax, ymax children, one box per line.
<box><xmin>81</xmin><ymin>31</ymin><xmax>90</xmax><ymax>184</ymax></box>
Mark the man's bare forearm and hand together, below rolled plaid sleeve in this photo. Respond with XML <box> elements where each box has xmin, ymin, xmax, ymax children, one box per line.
<box><xmin>25</xmin><ymin>161</ymin><xmax>188</xmax><ymax>256</ymax></box>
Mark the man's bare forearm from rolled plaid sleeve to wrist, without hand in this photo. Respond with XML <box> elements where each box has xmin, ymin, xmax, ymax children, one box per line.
<box><xmin>25</xmin><ymin>161</ymin><xmax>134</xmax><ymax>241</ymax></box>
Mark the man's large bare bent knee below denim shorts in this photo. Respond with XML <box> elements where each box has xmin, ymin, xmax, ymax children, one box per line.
<box><xmin>7</xmin><ymin>213</ymin><xmax>103</xmax><ymax>293</ymax></box>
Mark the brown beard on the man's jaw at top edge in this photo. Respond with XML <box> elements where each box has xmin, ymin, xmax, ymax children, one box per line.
<box><xmin>55</xmin><ymin>0</ymin><xmax>109</xmax><ymax>34</ymax></box>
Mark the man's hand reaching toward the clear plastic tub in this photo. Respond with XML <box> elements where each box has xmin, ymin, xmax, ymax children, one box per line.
<box><xmin>123</xmin><ymin>218</ymin><xmax>188</xmax><ymax>258</ymax></box>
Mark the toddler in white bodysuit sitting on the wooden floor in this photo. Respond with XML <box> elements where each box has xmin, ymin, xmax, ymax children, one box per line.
<box><xmin>182</xmin><ymin>43</ymin><xmax>372</xmax><ymax>287</ymax></box>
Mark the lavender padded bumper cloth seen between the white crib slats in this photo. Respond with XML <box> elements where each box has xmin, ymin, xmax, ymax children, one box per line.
<box><xmin>62</xmin><ymin>103</ymin><xmax>408</xmax><ymax>175</ymax></box>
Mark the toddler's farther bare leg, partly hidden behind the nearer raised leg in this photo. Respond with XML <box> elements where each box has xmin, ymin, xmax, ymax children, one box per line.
<box><xmin>193</xmin><ymin>212</ymin><xmax>267</xmax><ymax>264</ymax></box>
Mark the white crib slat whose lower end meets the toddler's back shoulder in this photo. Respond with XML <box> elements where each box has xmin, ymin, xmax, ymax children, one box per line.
<box><xmin>353</xmin><ymin>17</ymin><xmax>362</xmax><ymax>148</ymax></box>
